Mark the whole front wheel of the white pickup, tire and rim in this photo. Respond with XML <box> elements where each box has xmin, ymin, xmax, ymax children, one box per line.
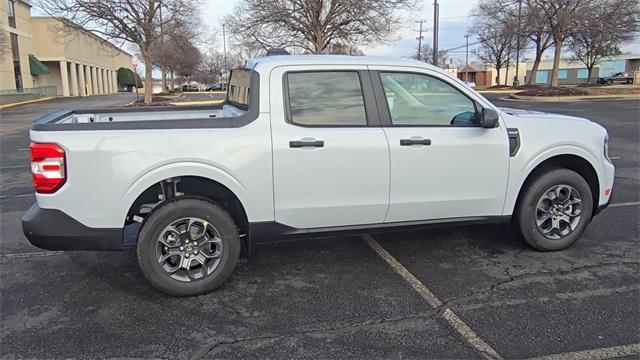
<box><xmin>515</xmin><ymin>169</ymin><xmax>593</xmax><ymax>251</ymax></box>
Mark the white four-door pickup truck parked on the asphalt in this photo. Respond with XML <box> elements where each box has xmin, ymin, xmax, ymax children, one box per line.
<box><xmin>23</xmin><ymin>56</ymin><xmax>614</xmax><ymax>296</ymax></box>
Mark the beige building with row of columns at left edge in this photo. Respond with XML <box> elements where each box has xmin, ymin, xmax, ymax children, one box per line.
<box><xmin>0</xmin><ymin>0</ymin><xmax>133</xmax><ymax>96</ymax></box>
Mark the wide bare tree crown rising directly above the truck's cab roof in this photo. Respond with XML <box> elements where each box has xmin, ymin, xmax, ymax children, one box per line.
<box><xmin>225</xmin><ymin>0</ymin><xmax>416</xmax><ymax>54</ymax></box>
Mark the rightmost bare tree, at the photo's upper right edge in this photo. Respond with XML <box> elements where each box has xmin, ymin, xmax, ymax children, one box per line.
<box><xmin>567</xmin><ymin>0</ymin><xmax>640</xmax><ymax>84</ymax></box>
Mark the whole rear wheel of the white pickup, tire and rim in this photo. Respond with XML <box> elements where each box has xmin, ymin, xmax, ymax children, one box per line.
<box><xmin>137</xmin><ymin>199</ymin><xmax>240</xmax><ymax>296</ymax></box>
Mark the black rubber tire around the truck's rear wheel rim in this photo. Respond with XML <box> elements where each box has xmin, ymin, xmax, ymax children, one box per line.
<box><xmin>137</xmin><ymin>199</ymin><xmax>241</xmax><ymax>296</ymax></box>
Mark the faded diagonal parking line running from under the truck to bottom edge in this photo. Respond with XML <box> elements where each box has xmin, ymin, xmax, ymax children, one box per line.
<box><xmin>362</xmin><ymin>234</ymin><xmax>502</xmax><ymax>359</ymax></box>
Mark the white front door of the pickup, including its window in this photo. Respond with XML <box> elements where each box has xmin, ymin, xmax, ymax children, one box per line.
<box><xmin>372</xmin><ymin>66</ymin><xmax>509</xmax><ymax>222</ymax></box>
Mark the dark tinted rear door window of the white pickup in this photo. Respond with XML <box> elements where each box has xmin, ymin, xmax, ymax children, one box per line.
<box><xmin>287</xmin><ymin>72</ymin><xmax>367</xmax><ymax>125</ymax></box>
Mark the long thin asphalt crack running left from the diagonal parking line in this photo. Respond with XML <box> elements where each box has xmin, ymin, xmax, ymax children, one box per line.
<box><xmin>190</xmin><ymin>310</ymin><xmax>442</xmax><ymax>360</ymax></box>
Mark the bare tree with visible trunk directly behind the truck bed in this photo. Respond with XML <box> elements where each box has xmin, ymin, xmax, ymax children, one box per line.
<box><xmin>38</xmin><ymin>0</ymin><xmax>196</xmax><ymax>104</ymax></box>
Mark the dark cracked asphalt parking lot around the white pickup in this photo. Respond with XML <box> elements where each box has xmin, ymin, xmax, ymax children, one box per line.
<box><xmin>0</xmin><ymin>94</ymin><xmax>640</xmax><ymax>359</ymax></box>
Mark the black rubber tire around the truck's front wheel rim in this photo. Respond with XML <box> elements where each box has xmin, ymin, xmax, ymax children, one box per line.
<box><xmin>514</xmin><ymin>168</ymin><xmax>593</xmax><ymax>251</ymax></box>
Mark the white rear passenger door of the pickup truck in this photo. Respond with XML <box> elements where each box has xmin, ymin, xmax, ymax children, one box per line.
<box><xmin>270</xmin><ymin>65</ymin><xmax>390</xmax><ymax>228</ymax></box>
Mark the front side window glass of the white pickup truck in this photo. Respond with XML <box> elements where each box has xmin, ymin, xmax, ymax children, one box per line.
<box><xmin>380</xmin><ymin>73</ymin><xmax>479</xmax><ymax>126</ymax></box>
